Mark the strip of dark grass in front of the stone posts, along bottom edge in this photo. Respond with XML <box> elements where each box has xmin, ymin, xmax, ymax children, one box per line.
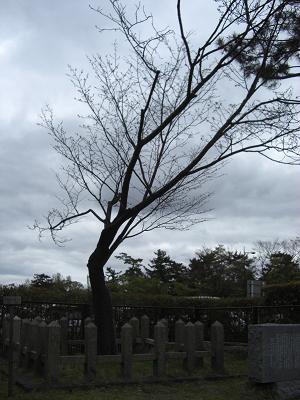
<box><xmin>0</xmin><ymin>378</ymin><xmax>284</xmax><ymax>400</ymax></box>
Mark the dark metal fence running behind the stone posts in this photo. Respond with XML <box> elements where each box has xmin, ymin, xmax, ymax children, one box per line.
<box><xmin>0</xmin><ymin>302</ymin><xmax>300</xmax><ymax>342</ymax></box>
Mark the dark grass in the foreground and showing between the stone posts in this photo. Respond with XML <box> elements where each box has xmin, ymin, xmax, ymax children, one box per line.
<box><xmin>0</xmin><ymin>353</ymin><xmax>300</xmax><ymax>400</ymax></box>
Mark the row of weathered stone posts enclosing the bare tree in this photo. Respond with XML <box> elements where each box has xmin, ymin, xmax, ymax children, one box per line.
<box><xmin>2</xmin><ymin>316</ymin><xmax>224</xmax><ymax>382</ymax></box>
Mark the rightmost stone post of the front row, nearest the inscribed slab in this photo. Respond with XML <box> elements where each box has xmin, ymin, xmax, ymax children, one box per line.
<box><xmin>211</xmin><ymin>321</ymin><xmax>224</xmax><ymax>373</ymax></box>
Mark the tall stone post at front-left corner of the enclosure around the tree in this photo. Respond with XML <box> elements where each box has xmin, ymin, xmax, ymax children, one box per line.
<box><xmin>46</xmin><ymin>321</ymin><xmax>60</xmax><ymax>384</ymax></box>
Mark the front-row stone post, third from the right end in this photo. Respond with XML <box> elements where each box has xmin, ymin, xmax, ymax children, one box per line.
<box><xmin>153</xmin><ymin>321</ymin><xmax>166</xmax><ymax>377</ymax></box>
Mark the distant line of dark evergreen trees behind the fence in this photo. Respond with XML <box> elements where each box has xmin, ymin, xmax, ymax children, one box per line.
<box><xmin>0</xmin><ymin>238</ymin><xmax>300</xmax><ymax>302</ymax></box>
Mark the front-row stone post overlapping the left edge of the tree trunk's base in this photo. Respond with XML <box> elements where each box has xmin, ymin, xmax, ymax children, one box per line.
<box><xmin>84</xmin><ymin>322</ymin><xmax>97</xmax><ymax>381</ymax></box>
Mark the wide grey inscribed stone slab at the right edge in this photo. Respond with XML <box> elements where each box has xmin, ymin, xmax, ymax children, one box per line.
<box><xmin>248</xmin><ymin>324</ymin><xmax>300</xmax><ymax>383</ymax></box>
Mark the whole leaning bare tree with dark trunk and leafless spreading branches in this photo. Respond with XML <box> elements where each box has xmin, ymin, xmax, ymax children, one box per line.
<box><xmin>35</xmin><ymin>0</ymin><xmax>299</xmax><ymax>353</ymax></box>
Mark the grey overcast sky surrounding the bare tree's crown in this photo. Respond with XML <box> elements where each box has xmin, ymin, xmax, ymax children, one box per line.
<box><xmin>0</xmin><ymin>0</ymin><xmax>300</xmax><ymax>283</ymax></box>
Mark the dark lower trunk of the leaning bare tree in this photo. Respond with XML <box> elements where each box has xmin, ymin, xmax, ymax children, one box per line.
<box><xmin>88</xmin><ymin>238</ymin><xmax>117</xmax><ymax>354</ymax></box>
